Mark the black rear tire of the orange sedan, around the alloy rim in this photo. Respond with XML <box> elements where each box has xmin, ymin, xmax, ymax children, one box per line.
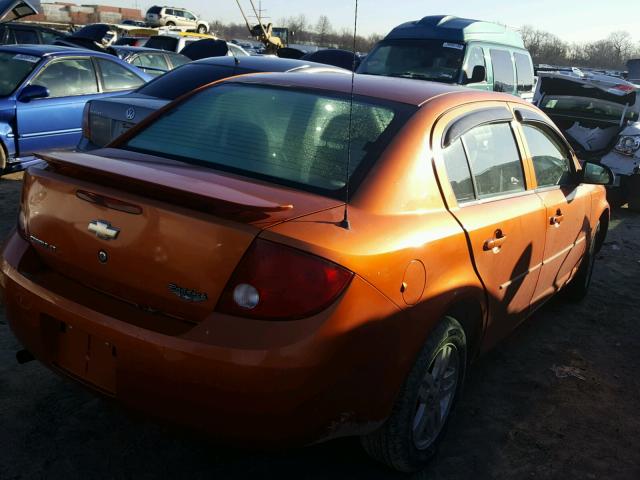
<box><xmin>361</xmin><ymin>317</ymin><xmax>467</xmax><ymax>472</ymax></box>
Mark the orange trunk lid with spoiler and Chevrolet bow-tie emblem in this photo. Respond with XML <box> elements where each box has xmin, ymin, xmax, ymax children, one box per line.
<box><xmin>23</xmin><ymin>150</ymin><xmax>340</xmax><ymax>322</ymax></box>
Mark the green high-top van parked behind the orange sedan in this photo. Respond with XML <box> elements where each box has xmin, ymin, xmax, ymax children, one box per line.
<box><xmin>358</xmin><ymin>15</ymin><xmax>534</xmax><ymax>100</ymax></box>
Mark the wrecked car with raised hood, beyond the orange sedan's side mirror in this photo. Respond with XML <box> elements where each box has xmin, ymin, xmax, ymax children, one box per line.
<box><xmin>534</xmin><ymin>68</ymin><xmax>640</xmax><ymax>210</ymax></box>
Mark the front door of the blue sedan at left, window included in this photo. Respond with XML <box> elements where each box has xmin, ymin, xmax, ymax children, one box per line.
<box><xmin>17</xmin><ymin>57</ymin><xmax>99</xmax><ymax>156</ymax></box>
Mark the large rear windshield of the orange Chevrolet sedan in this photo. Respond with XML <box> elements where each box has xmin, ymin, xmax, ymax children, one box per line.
<box><xmin>124</xmin><ymin>84</ymin><xmax>414</xmax><ymax>198</ymax></box>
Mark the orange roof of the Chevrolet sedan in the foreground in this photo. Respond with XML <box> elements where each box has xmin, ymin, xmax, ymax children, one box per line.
<box><xmin>224</xmin><ymin>73</ymin><xmax>518</xmax><ymax>107</ymax></box>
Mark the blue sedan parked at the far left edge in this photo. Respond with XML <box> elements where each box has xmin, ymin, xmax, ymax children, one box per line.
<box><xmin>0</xmin><ymin>45</ymin><xmax>153</xmax><ymax>173</ymax></box>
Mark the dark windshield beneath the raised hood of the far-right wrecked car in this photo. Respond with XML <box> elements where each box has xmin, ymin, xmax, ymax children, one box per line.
<box><xmin>540</xmin><ymin>95</ymin><xmax>638</xmax><ymax>123</ymax></box>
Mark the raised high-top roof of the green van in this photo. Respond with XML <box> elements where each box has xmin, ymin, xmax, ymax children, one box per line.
<box><xmin>385</xmin><ymin>15</ymin><xmax>524</xmax><ymax>49</ymax></box>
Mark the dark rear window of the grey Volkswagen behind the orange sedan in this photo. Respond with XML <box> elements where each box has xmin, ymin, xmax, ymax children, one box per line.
<box><xmin>138</xmin><ymin>64</ymin><xmax>240</xmax><ymax>100</ymax></box>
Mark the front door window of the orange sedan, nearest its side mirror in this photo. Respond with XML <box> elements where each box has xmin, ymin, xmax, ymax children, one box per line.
<box><xmin>522</xmin><ymin>125</ymin><xmax>571</xmax><ymax>188</ymax></box>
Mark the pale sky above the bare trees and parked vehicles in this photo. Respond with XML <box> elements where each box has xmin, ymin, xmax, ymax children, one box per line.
<box><xmin>116</xmin><ymin>0</ymin><xmax>640</xmax><ymax>41</ymax></box>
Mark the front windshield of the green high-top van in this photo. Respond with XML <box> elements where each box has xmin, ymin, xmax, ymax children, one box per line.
<box><xmin>358</xmin><ymin>39</ymin><xmax>464</xmax><ymax>83</ymax></box>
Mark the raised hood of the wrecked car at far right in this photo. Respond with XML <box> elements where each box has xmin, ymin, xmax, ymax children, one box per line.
<box><xmin>534</xmin><ymin>69</ymin><xmax>640</xmax><ymax>112</ymax></box>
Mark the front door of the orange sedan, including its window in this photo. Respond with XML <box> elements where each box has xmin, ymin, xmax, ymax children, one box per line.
<box><xmin>519</xmin><ymin>109</ymin><xmax>591</xmax><ymax>305</ymax></box>
